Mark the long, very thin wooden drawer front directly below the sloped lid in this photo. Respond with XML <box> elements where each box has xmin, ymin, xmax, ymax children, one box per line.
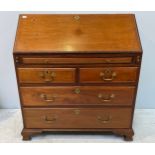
<box><xmin>21</xmin><ymin>57</ymin><xmax>132</xmax><ymax>64</ymax></box>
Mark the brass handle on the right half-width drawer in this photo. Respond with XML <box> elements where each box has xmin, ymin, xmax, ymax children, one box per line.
<box><xmin>100</xmin><ymin>69</ymin><xmax>117</xmax><ymax>81</ymax></box>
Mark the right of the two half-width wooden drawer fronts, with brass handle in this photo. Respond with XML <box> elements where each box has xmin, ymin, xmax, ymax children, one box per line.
<box><xmin>80</xmin><ymin>67</ymin><xmax>138</xmax><ymax>83</ymax></box>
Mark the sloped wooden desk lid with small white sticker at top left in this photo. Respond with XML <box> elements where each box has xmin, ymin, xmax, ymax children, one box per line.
<box><xmin>14</xmin><ymin>14</ymin><xmax>142</xmax><ymax>53</ymax></box>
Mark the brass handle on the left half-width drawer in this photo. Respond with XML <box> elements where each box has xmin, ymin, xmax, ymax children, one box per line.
<box><xmin>39</xmin><ymin>71</ymin><xmax>56</xmax><ymax>82</ymax></box>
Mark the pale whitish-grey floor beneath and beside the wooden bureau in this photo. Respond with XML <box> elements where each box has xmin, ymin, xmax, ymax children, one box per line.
<box><xmin>0</xmin><ymin>109</ymin><xmax>155</xmax><ymax>143</ymax></box>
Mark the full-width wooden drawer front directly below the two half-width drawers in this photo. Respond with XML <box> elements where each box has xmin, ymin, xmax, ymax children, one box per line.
<box><xmin>20</xmin><ymin>86</ymin><xmax>135</xmax><ymax>106</ymax></box>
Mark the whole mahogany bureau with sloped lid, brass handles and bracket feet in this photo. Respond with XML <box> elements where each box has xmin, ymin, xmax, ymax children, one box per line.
<box><xmin>14</xmin><ymin>14</ymin><xmax>142</xmax><ymax>140</ymax></box>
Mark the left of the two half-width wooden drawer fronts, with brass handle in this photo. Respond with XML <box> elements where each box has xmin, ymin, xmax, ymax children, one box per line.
<box><xmin>18</xmin><ymin>68</ymin><xmax>75</xmax><ymax>83</ymax></box>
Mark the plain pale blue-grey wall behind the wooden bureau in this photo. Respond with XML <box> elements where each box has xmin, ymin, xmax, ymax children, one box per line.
<box><xmin>0</xmin><ymin>12</ymin><xmax>155</xmax><ymax>109</ymax></box>
